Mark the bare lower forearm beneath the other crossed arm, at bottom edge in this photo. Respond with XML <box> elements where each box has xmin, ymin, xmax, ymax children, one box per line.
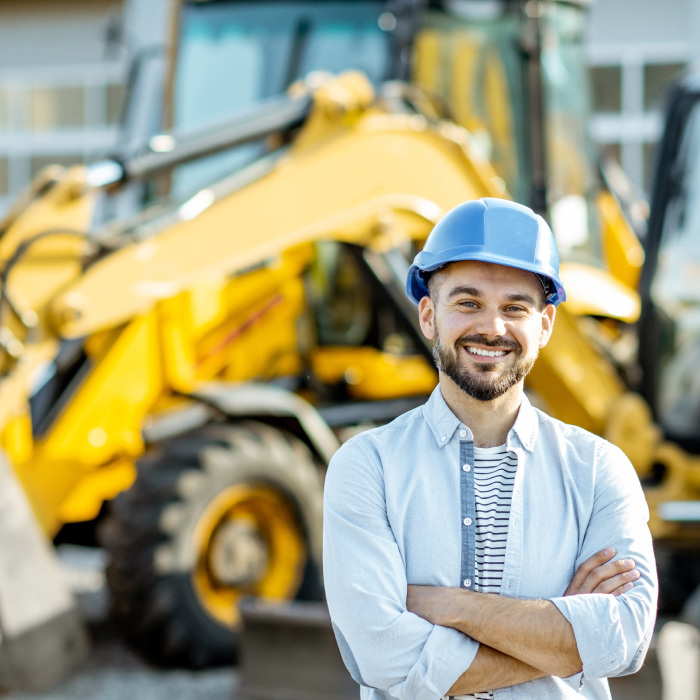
<box><xmin>447</xmin><ymin>644</ymin><xmax>547</xmax><ymax>695</ymax></box>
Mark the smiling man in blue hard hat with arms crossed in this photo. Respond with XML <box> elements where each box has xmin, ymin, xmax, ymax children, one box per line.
<box><xmin>324</xmin><ymin>199</ymin><xmax>657</xmax><ymax>700</ymax></box>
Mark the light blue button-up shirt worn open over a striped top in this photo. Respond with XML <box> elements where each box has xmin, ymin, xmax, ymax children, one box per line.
<box><xmin>323</xmin><ymin>386</ymin><xmax>657</xmax><ymax>700</ymax></box>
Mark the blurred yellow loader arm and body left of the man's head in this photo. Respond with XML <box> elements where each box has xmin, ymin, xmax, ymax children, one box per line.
<box><xmin>0</xmin><ymin>74</ymin><xmax>500</xmax><ymax>534</ymax></box>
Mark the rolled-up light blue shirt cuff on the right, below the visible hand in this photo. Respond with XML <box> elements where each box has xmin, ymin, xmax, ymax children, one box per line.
<box><xmin>551</xmin><ymin>593</ymin><xmax>627</xmax><ymax>690</ymax></box>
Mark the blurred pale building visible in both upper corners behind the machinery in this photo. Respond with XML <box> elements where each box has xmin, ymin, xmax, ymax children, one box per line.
<box><xmin>0</xmin><ymin>0</ymin><xmax>700</xmax><ymax>212</ymax></box>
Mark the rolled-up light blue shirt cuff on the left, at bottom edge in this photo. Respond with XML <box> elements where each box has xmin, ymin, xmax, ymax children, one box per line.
<box><xmin>390</xmin><ymin>625</ymin><xmax>479</xmax><ymax>700</ymax></box>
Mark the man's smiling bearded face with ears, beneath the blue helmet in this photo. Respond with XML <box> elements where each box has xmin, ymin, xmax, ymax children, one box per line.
<box><xmin>419</xmin><ymin>261</ymin><xmax>555</xmax><ymax>401</ymax></box>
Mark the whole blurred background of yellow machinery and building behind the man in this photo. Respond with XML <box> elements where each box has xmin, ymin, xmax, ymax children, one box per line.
<box><xmin>0</xmin><ymin>0</ymin><xmax>700</xmax><ymax>700</ymax></box>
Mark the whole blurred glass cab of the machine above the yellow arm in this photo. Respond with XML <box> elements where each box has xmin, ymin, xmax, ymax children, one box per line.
<box><xmin>127</xmin><ymin>0</ymin><xmax>601</xmax><ymax>219</ymax></box>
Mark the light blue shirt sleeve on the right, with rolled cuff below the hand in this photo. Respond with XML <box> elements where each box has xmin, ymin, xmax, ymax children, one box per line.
<box><xmin>552</xmin><ymin>443</ymin><xmax>658</xmax><ymax>687</ymax></box>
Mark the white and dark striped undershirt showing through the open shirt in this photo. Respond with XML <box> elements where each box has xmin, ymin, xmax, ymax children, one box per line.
<box><xmin>458</xmin><ymin>445</ymin><xmax>518</xmax><ymax>700</ymax></box>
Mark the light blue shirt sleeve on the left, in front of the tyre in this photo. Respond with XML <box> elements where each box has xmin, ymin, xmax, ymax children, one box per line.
<box><xmin>323</xmin><ymin>439</ymin><xmax>479</xmax><ymax>700</ymax></box>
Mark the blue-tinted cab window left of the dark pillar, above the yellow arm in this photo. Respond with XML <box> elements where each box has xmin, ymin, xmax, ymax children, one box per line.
<box><xmin>164</xmin><ymin>0</ymin><xmax>391</xmax><ymax>198</ymax></box>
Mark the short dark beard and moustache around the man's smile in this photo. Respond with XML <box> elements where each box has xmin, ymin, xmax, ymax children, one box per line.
<box><xmin>433</xmin><ymin>332</ymin><xmax>537</xmax><ymax>401</ymax></box>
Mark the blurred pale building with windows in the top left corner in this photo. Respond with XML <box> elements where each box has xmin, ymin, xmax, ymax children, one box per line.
<box><xmin>0</xmin><ymin>0</ymin><xmax>127</xmax><ymax>216</ymax></box>
